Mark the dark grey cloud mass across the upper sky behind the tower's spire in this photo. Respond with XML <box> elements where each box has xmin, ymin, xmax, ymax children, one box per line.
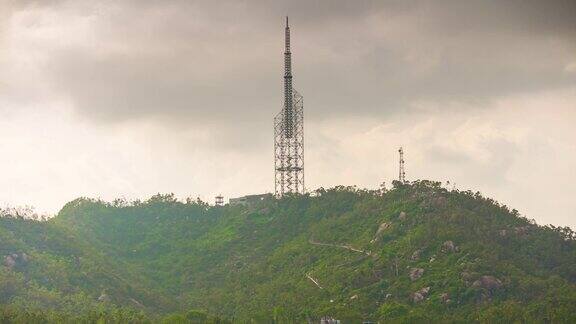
<box><xmin>3</xmin><ymin>0</ymin><xmax>576</xmax><ymax>125</ymax></box>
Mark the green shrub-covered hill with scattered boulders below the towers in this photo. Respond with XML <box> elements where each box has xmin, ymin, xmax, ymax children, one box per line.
<box><xmin>0</xmin><ymin>181</ymin><xmax>576</xmax><ymax>323</ymax></box>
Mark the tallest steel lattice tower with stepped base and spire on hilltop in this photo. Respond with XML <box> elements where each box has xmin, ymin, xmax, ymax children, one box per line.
<box><xmin>274</xmin><ymin>17</ymin><xmax>304</xmax><ymax>197</ymax></box>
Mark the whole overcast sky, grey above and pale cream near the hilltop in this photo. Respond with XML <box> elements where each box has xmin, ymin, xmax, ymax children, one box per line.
<box><xmin>0</xmin><ymin>0</ymin><xmax>576</xmax><ymax>228</ymax></box>
